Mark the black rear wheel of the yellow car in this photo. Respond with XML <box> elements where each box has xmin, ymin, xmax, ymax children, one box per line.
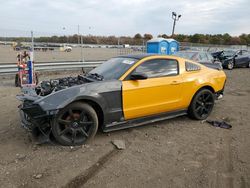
<box><xmin>188</xmin><ymin>89</ymin><xmax>215</xmax><ymax>120</ymax></box>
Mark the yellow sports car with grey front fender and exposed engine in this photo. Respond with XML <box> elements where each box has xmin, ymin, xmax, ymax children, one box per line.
<box><xmin>17</xmin><ymin>54</ymin><xmax>226</xmax><ymax>145</ymax></box>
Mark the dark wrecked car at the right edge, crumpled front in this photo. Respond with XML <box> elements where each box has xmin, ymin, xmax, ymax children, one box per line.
<box><xmin>212</xmin><ymin>50</ymin><xmax>250</xmax><ymax>70</ymax></box>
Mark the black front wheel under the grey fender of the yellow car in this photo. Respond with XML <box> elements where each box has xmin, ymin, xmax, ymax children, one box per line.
<box><xmin>52</xmin><ymin>102</ymin><xmax>98</xmax><ymax>146</ymax></box>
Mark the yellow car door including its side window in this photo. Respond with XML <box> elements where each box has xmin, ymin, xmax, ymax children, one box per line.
<box><xmin>122</xmin><ymin>59</ymin><xmax>182</xmax><ymax>120</ymax></box>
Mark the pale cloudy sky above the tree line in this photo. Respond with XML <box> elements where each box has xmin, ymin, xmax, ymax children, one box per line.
<box><xmin>0</xmin><ymin>0</ymin><xmax>250</xmax><ymax>37</ymax></box>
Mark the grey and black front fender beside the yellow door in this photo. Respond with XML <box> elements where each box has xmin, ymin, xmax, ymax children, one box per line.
<box><xmin>30</xmin><ymin>80</ymin><xmax>123</xmax><ymax>123</ymax></box>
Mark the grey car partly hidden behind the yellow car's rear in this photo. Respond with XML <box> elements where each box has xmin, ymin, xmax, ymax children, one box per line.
<box><xmin>174</xmin><ymin>51</ymin><xmax>222</xmax><ymax>69</ymax></box>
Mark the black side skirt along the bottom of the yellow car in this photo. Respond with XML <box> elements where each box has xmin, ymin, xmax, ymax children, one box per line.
<box><xmin>103</xmin><ymin>109</ymin><xmax>187</xmax><ymax>132</ymax></box>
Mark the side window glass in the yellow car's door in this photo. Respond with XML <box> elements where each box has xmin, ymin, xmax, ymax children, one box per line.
<box><xmin>133</xmin><ymin>59</ymin><xmax>178</xmax><ymax>78</ymax></box>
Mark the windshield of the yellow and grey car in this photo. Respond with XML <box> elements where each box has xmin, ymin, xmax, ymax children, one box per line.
<box><xmin>88</xmin><ymin>57</ymin><xmax>137</xmax><ymax>80</ymax></box>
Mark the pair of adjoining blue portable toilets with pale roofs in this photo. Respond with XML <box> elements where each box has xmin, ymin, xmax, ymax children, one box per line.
<box><xmin>147</xmin><ymin>38</ymin><xmax>179</xmax><ymax>55</ymax></box>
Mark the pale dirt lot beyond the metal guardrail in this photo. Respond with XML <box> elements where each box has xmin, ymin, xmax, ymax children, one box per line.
<box><xmin>0</xmin><ymin>45</ymin><xmax>141</xmax><ymax>64</ymax></box>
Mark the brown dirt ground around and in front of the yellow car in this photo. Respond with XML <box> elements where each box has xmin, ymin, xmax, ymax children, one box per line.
<box><xmin>0</xmin><ymin>68</ymin><xmax>250</xmax><ymax>188</ymax></box>
